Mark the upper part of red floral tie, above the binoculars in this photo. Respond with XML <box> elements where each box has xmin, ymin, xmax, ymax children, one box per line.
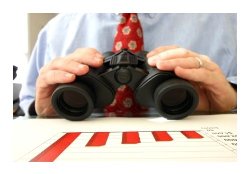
<box><xmin>113</xmin><ymin>13</ymin><xmax>144</xmax><ymax>53</ymax></box>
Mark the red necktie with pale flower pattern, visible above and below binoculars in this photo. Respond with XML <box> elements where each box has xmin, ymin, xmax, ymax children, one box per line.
<box><xmin>104</xmin><ymin>13</ymin><xmax>147</xmax><ymax>116</ymax></box>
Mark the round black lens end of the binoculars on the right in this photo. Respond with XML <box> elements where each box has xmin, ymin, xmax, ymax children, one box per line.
<box><xmin>154</xmin><ymin>79</ymin><xmax>199</xmax><ymax>119</ymax></box>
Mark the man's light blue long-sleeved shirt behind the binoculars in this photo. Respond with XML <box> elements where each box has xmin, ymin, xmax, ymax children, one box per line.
<box><xmin>20</xmin><ymin>13</ymin><xmax>237</xmax><ymax>114</ymax></box>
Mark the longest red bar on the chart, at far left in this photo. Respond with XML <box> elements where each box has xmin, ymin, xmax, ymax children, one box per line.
<box><xmin>30</xmin><ymin>132</ymin><xmax>80</xmax><ymax>162</ymax></box>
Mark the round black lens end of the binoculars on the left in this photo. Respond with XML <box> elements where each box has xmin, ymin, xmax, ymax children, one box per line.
<box><xmin>52</xmin><ymin>84</ymin><xmax>94</xmax><ymax>121</ymax></box>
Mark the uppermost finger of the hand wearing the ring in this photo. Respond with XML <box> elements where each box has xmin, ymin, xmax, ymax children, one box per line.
<box><xmin>148</xmin><ymin>48</ymin><xmax>199</xmax><ymax>66</ymax></box>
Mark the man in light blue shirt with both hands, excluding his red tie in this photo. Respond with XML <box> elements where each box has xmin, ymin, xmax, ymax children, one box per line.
<box><xmin>20</xmin><ymin>14</ymin><xmax>237</xmax><ymax>116</ymax></box>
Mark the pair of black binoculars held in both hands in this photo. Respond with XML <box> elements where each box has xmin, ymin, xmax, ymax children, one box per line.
<box><xmin>51</xmin><ymin>49</ymin><xmax>199</xmax><ymax>121</ymax></box>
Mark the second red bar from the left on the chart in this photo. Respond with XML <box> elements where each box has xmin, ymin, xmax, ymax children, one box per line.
<box><xmin>86</xmin><ymin>132</ymin><xmax>109</xmax><ymax>146</ymax></box>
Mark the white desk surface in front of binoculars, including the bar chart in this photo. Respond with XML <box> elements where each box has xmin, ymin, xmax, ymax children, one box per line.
<box><xmin>12</xmin><ymin>114</ymin><xmax>237</xmax><ymax>162</ymax></box>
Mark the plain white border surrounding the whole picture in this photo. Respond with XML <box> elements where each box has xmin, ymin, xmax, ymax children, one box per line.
<box><xmin>0</xmin><ymin>0</ymin><xmax>249</xmax><ymax>174</ymax></box>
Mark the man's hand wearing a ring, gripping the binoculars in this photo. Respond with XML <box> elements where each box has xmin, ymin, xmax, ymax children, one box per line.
<box><xmin>147</xmin><ymin>46</ymin><xmax>237</xmax><ymax>112</ymax></box>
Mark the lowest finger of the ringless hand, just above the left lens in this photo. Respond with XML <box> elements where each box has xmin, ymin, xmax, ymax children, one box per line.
<box><xmin>36</xmin><ymin>70</ymin><xmax>76</xmax><ymax>88</ymax></box>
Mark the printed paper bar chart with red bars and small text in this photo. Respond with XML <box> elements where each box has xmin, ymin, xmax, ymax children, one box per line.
<box><xmin>17</xmin><ymin>127</ymin><xmax>237</xmax><ymax>162</ymax></box>
